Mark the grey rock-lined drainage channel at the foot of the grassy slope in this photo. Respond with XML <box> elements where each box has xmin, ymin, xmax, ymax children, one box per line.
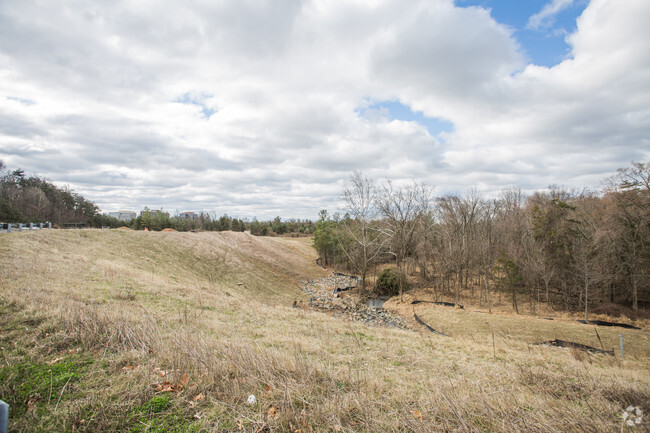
<box><xmin>294</xmin><ymin>273</ymin><xmax>408</xmax><ymax>329</ymax></box>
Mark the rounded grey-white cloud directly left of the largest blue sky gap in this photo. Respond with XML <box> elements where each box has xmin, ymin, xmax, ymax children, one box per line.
<box><xmin>371</xmin><ymin>2</ymin><xmax>523</xmax><ymax>103</ymax></box>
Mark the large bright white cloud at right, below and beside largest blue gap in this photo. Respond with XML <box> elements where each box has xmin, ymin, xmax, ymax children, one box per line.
<box><xmin>430</xmin><ymin>0</ymin><xmax>650</xmax><ymax>186</ymax></box>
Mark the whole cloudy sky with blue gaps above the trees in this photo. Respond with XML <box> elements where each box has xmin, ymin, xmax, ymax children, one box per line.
<box><xmin>0</xmin><ymin>0</ymin><xmax>650</xmax><ymax>220</ymax></box>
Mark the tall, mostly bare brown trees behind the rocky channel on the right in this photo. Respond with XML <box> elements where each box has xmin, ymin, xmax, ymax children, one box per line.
<box><xmin>313</xmin><ymin>162</ymin><xmax>650</xmax><ymax>316</ymax></box>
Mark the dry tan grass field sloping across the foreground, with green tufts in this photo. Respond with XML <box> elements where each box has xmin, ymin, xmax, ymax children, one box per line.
<box><xmin>0</xmin><ymin>230</ymin><xmax>650</xmax><ymax>433</ymax></box>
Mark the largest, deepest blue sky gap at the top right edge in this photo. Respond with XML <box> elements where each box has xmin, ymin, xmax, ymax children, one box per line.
<box><xmin>455</xmin><ymin>0</ymin><xmax>588</xmax><ymax>67</ymax></box>
